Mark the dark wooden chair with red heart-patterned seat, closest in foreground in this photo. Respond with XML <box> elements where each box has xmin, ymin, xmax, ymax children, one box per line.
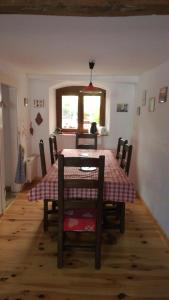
<box><xmin>57</xmin><ymin>155</ymin><xmax>105</xmax><ymax>269</ymax></box>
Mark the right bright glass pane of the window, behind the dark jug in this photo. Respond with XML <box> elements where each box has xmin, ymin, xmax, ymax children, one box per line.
<box><xmin>83</xmin><ymin>96</ymin><xmax>100</xmax><ymax>129</ymax></box>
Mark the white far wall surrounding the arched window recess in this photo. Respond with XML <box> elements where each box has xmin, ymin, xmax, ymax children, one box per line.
<box><xmin>29</xmin><ymin>75</ymin><xmax>137</xmax><ymax>170</ymax></box>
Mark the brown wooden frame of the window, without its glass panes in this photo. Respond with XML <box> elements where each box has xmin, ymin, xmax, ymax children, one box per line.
<box><xmin>56</xmin><ymin>86</ymin><xmax>106</xmax><ymax>133</ymax></box>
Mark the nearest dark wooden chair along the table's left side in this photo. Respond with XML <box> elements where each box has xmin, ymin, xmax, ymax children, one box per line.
<box><xmin>39</xmin><ymin>140</ymin><xmax>57</xmax><ymax>231</ymax></box>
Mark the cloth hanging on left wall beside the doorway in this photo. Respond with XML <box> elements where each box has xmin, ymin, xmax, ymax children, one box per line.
<box><xmin>15</xmin><ymin>144</ymin><xmax>26</xmax><ymax>184</ymax></box>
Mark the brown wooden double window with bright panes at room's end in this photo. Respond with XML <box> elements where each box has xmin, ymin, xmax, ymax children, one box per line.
<box><xmin>56</xmin><ymin>86</ymin><xmax>106</xmax><ymax>132</ymax></box>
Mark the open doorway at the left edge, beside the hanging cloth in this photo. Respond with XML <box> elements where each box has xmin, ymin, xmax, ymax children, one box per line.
<box><xmin>1</xmin><ymin>84</ymin><xmax>18</xmax><ymax>207</ymax></box>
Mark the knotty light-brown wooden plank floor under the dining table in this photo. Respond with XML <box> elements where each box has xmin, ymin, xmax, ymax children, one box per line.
<box><xmin>0</xmin><ymin>192</ymin><xmax>169</xmax><ymax>300</ymax></box>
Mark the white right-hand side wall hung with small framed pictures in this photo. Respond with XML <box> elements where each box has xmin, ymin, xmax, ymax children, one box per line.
<box><xmin>133</xmin><ymin>61</ymin><xmax>169</xmax><ymax>236</ymax></box>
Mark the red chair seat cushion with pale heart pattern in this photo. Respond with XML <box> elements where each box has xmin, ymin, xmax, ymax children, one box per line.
<box><xmin>64</xmin><ymin>209</ymin><xmax>96</xmax><ymax>232</ymax></box>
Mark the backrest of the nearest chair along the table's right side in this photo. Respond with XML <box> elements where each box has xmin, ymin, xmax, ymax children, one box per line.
<box><xmin>120</xmin><ymin>144</ymin><xmax>133</xmax><ymax>175</ymax></box>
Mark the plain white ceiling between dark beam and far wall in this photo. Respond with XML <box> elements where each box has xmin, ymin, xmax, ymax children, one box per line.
<box><xmin>0</xmin><ymin>15</ymin><xmax>169</xmax><ymax>76</ymax></box>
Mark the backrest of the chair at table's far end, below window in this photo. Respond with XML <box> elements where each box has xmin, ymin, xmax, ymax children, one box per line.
<box><xmin>76</xmin><ymin>133</ymin><xmax>97</xmax><ymax>149</ymax></box>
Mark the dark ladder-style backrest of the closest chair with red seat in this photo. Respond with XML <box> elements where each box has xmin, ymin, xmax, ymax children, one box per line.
<box><xmin>58</xmin><ymin>154</ymin><xmax>105</xmax><ymax>214</ymax></box>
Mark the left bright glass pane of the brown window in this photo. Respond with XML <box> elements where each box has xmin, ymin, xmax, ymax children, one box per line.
<box><xmin>62</xmin><ymin>96</ymin><xmax>78</xmax><ymax>129</ymax></box>
